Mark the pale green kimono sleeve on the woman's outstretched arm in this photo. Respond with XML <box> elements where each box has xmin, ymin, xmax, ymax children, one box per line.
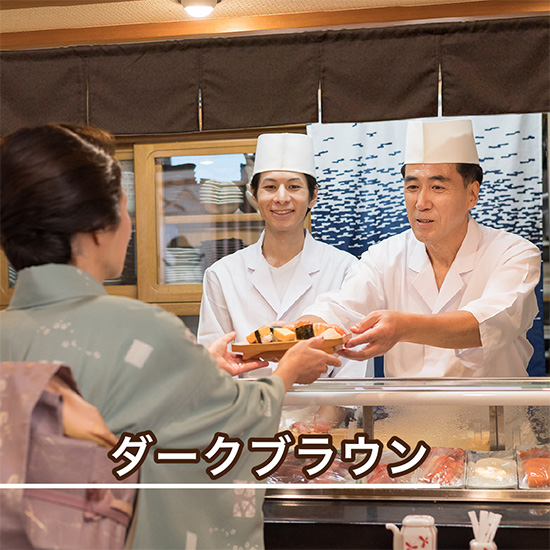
<box><xmin>102</xmin><ymin>306</ymin><xmax>284</xmax><ymax>458</ymax></box>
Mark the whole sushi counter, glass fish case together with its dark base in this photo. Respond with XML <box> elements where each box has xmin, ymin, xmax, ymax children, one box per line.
<box><xmin>264</xmin><ymin>378</ymin><xmax>550</xmax><ymax>550</ymax></box>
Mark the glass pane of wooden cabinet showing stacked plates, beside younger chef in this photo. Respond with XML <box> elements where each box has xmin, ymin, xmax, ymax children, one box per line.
<box><xmin>155</xmin><ymin>153</ymin><xmax>261</xmax><ymax>284</ymax></box>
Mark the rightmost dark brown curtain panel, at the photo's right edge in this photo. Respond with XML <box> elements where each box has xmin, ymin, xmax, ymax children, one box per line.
<box><xmin>441</xmin><ymin>17</ymin><xmax>550</xmax><ymax>116</ymax></box>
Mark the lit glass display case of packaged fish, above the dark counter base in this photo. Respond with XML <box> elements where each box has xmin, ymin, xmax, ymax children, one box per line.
<box><xmin>268</xmin><ymin>378</ymin><xmax>550</xmax><ymax>501</ymax></box>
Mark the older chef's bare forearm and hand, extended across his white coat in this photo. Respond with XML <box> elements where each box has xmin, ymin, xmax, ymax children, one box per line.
<box><xmin>340</xmin><ymin>310</ymin><xmax>481</xmax><ymax>359</ymax></box>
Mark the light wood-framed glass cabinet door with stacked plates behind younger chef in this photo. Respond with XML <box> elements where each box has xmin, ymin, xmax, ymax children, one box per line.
<box><xmin>135</xmin><ymin>139</ymin><xmax>263</xmax><ymax>315</ymax></box>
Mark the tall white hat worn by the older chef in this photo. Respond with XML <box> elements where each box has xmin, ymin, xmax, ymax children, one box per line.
<box><xmin>405</xmin><ymin>119</ymin><xmax>479</xmax><ymax>164</ymax></box>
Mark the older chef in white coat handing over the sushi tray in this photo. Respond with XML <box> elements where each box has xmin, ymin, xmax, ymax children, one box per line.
<box><xmin>302</xmin><ymin>120</ymin><xmax>541</xmax><ymax>377</ymax></box>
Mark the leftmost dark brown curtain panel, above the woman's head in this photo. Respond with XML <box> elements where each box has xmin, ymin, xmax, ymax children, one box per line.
<box><xmin>0</xmin><ymin>48</ymin><xmax>86</xmax><ymax>135</ymax></box>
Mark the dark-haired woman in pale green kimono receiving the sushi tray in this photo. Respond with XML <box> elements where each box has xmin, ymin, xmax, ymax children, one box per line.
<box><xmin>0</xmin><ymin>124</ymin><xmax>340</xmax><ymax>549</ymax></box>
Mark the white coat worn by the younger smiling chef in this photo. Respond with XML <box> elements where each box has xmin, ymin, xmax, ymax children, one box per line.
<box><xmin>197</xmin><ymin>231</ymin><xmax>374</xmax><ymax>378</ymax></box>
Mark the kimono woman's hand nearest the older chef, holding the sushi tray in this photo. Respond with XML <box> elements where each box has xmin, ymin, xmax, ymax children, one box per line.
<box><xmin>273</xmin><ymin>336</ymin><xmax>342</xmax><ymax>390</ymax></box>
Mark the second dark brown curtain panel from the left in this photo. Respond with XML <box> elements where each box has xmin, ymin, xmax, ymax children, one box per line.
<box><xmin>86</xmin><ymin>42</ymin><xmax>203</xmax><ymax>134</ymax></box>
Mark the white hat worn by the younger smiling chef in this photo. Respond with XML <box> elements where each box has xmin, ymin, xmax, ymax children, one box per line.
<box><xmin>252</xmin><ymin>133</ymin><xmax>316</xmax><ymax>177</ymax></box>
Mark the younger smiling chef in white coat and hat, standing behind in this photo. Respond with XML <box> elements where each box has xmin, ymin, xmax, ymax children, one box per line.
<box><xmin>197</xmin><ymin>133</ymin><xmax>373</xmax><ymax>378</ymax></box>
